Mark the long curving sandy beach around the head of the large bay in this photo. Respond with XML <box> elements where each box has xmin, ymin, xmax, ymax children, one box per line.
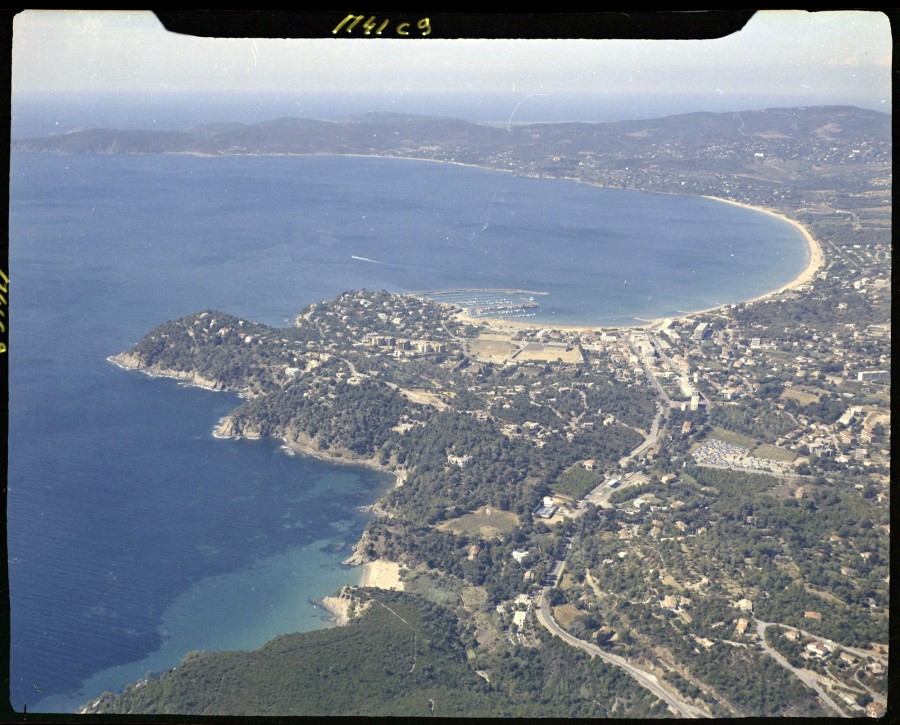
<box><xmin>442</xmin><ymin>196</ymin><xmax>825</xmax><ymax>332</ymax></box>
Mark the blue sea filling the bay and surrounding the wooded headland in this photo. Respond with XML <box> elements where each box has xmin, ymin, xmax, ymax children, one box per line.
<box><xmin>7</xmin><ymin>153</ymin><xmax>808</xmax><ymax>712</ymax></box>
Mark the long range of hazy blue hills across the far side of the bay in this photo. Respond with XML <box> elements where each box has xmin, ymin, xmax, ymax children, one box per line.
<box><xmin>12</xmin><ymin>106</ymin><xmax>892</xmax><ymax>211</ymax></box>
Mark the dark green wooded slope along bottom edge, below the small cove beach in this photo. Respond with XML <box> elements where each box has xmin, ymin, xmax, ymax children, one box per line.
<box><xmin>85</xmin><ymin>589</ymin><xmax>658</xmax><ymax>717</ymax></box>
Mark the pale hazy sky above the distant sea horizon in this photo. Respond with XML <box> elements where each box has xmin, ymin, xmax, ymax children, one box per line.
<box><xmin>12</xmin><ymin>10</ymin><xmax>893</xmax><ymax>127</ymax></box>
